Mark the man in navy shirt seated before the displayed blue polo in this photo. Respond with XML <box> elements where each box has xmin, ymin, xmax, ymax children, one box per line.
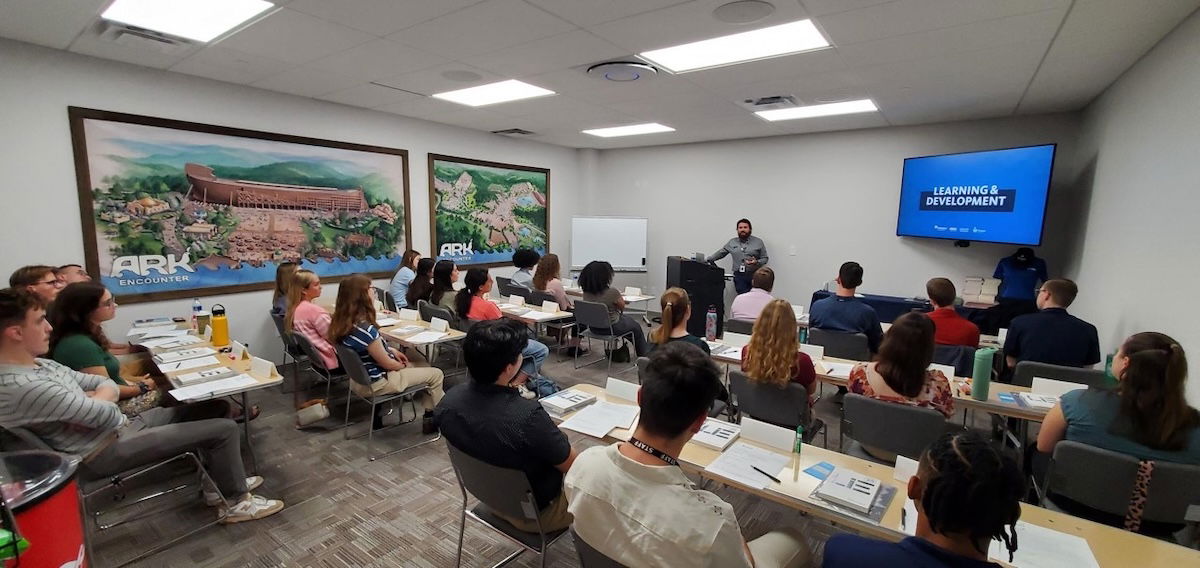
<box><xmin>1004</xmin><ymin>280</ymin><xmax>1100</xmax><ymax>367</ymax></box>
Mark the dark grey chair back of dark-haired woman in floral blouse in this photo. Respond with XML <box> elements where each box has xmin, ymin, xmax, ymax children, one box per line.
<box><xmin>838</xmin><ymin>393</ymin><xmax>948</xmax><ymax>464</ymax></box>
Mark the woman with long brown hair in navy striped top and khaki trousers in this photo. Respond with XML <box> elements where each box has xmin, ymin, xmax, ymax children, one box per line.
<box><xmin>329</xmin><ymin>274</ymin><xmax>443</xmax><ymax>434</ymax></box>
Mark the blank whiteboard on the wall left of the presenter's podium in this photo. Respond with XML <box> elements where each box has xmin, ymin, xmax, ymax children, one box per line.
<box><xmin>571</xmin><ymin>217</ymin><xmax>647</xmax><ymax>273</ymax></box>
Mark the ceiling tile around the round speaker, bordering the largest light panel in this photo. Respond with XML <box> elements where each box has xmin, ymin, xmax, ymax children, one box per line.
<box><xmin>588</xmin><ymin>0</ymin><xmax>808</xmax><ymax>53</ymax></box>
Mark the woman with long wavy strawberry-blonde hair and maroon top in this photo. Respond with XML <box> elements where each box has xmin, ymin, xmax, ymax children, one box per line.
<box><xmin>742</xmin><ymin>301</ymin><xmax>817</xmax><ymax>406</ymax></box>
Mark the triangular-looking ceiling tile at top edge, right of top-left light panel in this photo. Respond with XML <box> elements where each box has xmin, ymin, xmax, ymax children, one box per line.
<box><xmin>288</xmin><ymin>0</ymin><xmax>480</xmax><ymax>37</ymax></box>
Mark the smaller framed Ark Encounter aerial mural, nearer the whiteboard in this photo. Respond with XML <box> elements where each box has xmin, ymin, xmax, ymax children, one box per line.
<box><xmin>430</xmin><ymin>154</ymin><xmax>550</xmax><ymax>267</ymax></box>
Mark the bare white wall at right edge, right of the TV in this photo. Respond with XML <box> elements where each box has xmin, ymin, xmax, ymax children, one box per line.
<box><xmin>1072</xmin><ymin>12</ymin><xmax>1200</xmax><ymax>406</ymax></box>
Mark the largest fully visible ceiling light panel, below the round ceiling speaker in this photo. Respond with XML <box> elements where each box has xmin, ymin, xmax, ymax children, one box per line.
<box><xmin>638</xmin><ymin>19</ymin><xmax>829</xmax><ymax>73</ymax></box>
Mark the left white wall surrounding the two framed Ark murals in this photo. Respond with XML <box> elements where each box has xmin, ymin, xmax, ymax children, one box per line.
<box><xmin>0</xmin><ymin>40</ymin><xmax>581</xmax><ymax>360</ymax></box>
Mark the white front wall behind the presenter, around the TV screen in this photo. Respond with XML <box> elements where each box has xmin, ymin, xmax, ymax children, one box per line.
<box><xmin>587</xmin><ymin>114</ymin><xmax>1078</xmax><ymax>305</ymax></box>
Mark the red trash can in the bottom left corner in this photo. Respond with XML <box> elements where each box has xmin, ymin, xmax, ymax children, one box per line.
<box><xmin>0</xmin><ymin>452</ymin><xmax>88</xmax><ymax>568</ymax></box>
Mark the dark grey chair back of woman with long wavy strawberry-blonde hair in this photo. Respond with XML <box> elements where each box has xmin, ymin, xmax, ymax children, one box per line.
<box><xmin>730</xmin><ymin>369</ymin><xmax>829</xmax><ymax>447</ymax></box>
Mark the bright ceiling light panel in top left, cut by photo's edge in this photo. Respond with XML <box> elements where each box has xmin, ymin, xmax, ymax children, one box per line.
<box><xmin>100</xmin><ymin>0</ymin><xmax>275</xmax><ymax>42</ymax></box>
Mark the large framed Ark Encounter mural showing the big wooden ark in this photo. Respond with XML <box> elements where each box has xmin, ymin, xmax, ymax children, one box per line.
<box><xmin>68</xmin><ymin>107</ymin><xmax>412</xmax><ymax>303</ymax></box>
